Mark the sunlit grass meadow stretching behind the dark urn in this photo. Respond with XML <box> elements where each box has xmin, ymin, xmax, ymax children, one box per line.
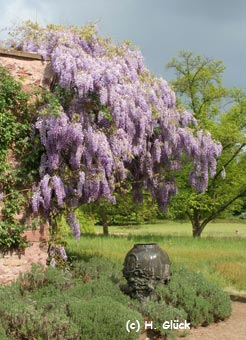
<box><xmin>67</xmin><ymin>222</ymin><xmax>246</xmax><ymax>293</ymax></box>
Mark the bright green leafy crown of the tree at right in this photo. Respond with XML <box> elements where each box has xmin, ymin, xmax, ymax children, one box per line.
<box><xmin>167</xmin><ymin>52</ymin><xmax>246</xmax><ymax>237</ymax></box>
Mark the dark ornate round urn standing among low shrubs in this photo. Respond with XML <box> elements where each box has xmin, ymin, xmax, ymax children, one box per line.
<box><xmin>123</xmin><ymin>243</ymin><xmax>171</xmax><ymax>300</ymax></box>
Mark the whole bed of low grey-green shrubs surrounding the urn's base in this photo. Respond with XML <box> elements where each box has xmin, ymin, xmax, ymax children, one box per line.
<box><xmin>0</xmin><ymin>257</ymin><xmax>231</xmax><ymax>340</ymax></box>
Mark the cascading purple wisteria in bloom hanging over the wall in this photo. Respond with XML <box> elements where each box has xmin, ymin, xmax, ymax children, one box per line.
<box><xmin>8</xmin><ymin>23</ymin><xmax>221</xmax><ymax>237</ymax></box>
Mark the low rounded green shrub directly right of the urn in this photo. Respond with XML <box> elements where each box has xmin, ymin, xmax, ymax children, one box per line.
<box><xmin>156</xmin><ymin>266</ymin><xmax>231</xmax><ymax>327</ymax></box>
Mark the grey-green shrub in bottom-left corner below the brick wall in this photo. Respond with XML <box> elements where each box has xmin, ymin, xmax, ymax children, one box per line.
<box><xmin>0</xmin><ymin>266</ymin><xmax>78</xmax><ymax>340</ymax></box>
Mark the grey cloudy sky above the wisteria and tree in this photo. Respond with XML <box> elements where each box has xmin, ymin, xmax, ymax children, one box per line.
<box><xmin>0</xmin><ymin>0</ymin><xmax>246</xmax><ymax>89</ymax></box>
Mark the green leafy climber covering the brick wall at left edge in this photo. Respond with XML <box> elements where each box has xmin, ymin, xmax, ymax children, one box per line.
<box><xmin>0</xmin><ymin>67</ymin><xmax>40</xmax><ymax>252</ymax></box>
